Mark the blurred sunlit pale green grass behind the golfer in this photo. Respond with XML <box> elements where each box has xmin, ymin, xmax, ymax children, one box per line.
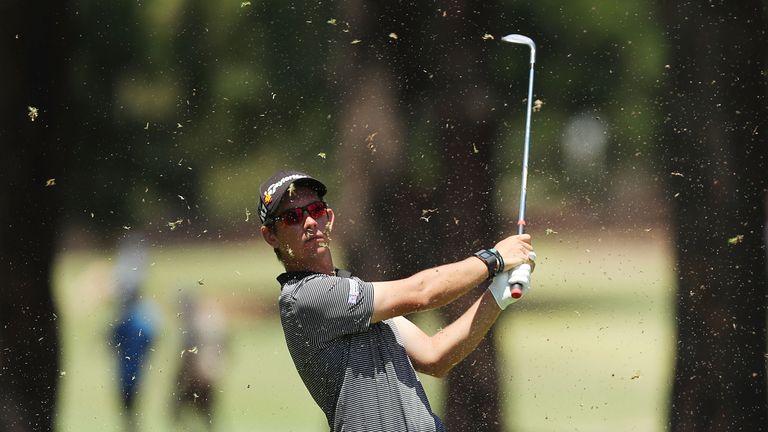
<box><xmin>55</xmin><ymin>230</ymin><xmax>674</xmax><ymax>432</ymax></box>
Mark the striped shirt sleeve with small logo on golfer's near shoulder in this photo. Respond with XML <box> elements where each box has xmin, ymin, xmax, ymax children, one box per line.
<box><xmin>294</xmin><ymin>276</ymin><xmax>373</xmax><ymax>342</ymax></box>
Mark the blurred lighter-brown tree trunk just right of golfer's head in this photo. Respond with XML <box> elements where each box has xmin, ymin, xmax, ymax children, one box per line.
<box><xmin>331</xmin><ymin>1</ymin><xmax>448</xmax><ymax>280</ymax></box>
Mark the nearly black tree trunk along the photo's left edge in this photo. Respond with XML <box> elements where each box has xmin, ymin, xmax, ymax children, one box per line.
<box><xmin>0</xmin><ymin>1</ymin><xmax>67</xmax><ymax>432</ymax></box>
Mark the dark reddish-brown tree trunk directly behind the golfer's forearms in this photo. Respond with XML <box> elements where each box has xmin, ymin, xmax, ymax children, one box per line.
<box><xmin>433</xmin><ymin>1</ymin><xmax>510</xmax><ymax>431</ymax></box>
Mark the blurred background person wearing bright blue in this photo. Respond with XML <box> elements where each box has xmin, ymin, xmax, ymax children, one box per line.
<box><xmin>112</xmin><ymin>234</ymin><xmax>159</xmax><ymax>431</ymax></box>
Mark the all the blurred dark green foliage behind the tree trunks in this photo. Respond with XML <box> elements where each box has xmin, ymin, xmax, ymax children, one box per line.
<box><xmin>67</xmin><ymin>0</ymin><xmax>665</xmax><ymax>235</ymax></box>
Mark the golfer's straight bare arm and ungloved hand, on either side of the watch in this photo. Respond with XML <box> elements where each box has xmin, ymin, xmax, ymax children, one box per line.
<box><xmin>371</xmin><ymin>234</ymin><xmax>533</xmax><ymax>322</ymax></box>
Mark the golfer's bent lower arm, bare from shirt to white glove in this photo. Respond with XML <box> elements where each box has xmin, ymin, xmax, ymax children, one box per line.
<box><xmin>394</xmin><ymin>290</ymin><xmax>501</xmax><ymax>377</ymax></box>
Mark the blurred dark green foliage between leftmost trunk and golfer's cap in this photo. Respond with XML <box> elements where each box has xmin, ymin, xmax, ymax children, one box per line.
<box><xmin>61</xmin><ymin>0</ymin><xmax>346</xmax><ymax>238</ymax></box>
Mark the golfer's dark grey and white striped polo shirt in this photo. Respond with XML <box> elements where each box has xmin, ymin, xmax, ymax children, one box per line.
<box><xmin>277</xmin><ymin>270</ymin><xmax>444</xmax><ymax>432</ymax></box>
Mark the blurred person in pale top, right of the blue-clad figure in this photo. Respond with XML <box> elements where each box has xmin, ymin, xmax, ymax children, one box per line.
<box><xmin>176</xmin><ymin>292</ymin><xmax>226</xmax><ymax>431</ymax></box>
